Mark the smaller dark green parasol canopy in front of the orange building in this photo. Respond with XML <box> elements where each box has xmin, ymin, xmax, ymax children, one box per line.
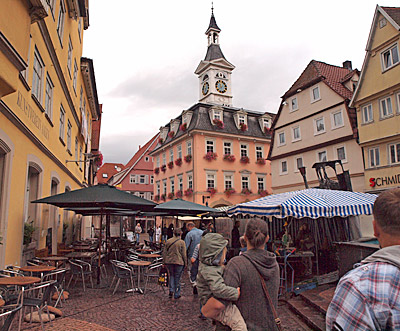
<box><xmin>154</xmin><ymin>199</ymin><xmax>218</xmax><ymax>216</ymax></box>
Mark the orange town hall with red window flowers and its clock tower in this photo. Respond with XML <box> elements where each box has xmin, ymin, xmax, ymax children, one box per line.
<box><xmin>151</xmin><ymin>13</ymin><xmax>274</xmax><ymax>207</ymax></box>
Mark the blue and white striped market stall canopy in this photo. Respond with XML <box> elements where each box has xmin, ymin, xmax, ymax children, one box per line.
<box><xmin>227</xmin><ymin>188</ymin><xmax>377</xmax><ymax>218</ymax></box>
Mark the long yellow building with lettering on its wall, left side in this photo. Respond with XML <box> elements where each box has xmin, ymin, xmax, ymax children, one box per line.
<box><xmin>0</xmin><ymin>0</ymin><xmax>100</xmax><ymax>267</ymax></box>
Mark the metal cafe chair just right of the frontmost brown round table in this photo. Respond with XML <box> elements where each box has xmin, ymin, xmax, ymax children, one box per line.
<box><xmin>22</xmin><ymin>281</ymin><xmax>55</xmax><ymax>331</ymax></box>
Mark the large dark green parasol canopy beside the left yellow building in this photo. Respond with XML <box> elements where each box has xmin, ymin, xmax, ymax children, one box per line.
<box><xmin>32</xmin><ymin>184</ymin><xmax>156</xmax><ymax>213</ymax></box>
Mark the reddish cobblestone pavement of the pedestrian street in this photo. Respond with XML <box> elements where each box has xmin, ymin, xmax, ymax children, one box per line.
<box><xmin>18</xmin><ymin>272</ymin><xmax>310</xmax><ymax>331</ymax></box>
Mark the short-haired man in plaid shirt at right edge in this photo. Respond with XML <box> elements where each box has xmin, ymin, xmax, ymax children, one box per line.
<box><xmin>326</xmin><ymin>188</ymin><xmax>400</xmax><ymax>331</ymax></box>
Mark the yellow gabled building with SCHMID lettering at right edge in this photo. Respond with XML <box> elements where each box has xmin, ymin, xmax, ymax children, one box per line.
<box><xmin>351</xmin><ymin>6</ymin><xmax>400</xmax><ymax>192</ymax></box>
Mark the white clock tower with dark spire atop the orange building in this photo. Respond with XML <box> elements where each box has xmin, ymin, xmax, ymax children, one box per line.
<box><xmin>195</xmin><ymin>8</ymin><xmax>235</xmax><ymax>106</ymax></box>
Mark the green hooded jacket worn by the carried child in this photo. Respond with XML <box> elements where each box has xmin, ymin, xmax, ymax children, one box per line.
<box><xmin>196</xmin><ymin>233</ymin><xmax>239</xmax><ymax>305</ymax></box>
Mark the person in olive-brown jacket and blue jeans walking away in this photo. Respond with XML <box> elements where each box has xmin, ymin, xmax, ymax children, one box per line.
<box><xmin>163</xmin><ymin>228</ymin><xmax>187</xmax><ymax>299</ymax></box>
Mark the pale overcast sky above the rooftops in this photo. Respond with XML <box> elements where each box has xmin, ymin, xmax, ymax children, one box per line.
<box><xmin>84</xmin><ymin>0</ymin><xmax>400</xmax><ymax>164</ymax></box>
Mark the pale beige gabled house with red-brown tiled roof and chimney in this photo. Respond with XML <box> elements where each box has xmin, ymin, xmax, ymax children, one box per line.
<box><xmin>268</xmin><ymin>60</ymin><xmax>364</xmax><ymax>194</ymax></box>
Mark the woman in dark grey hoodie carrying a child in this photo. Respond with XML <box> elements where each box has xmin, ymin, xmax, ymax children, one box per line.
<box><xmin>202</xmin><ymin>218</ymin><xmax>279</xmax><ymax>331</ymax></box>
